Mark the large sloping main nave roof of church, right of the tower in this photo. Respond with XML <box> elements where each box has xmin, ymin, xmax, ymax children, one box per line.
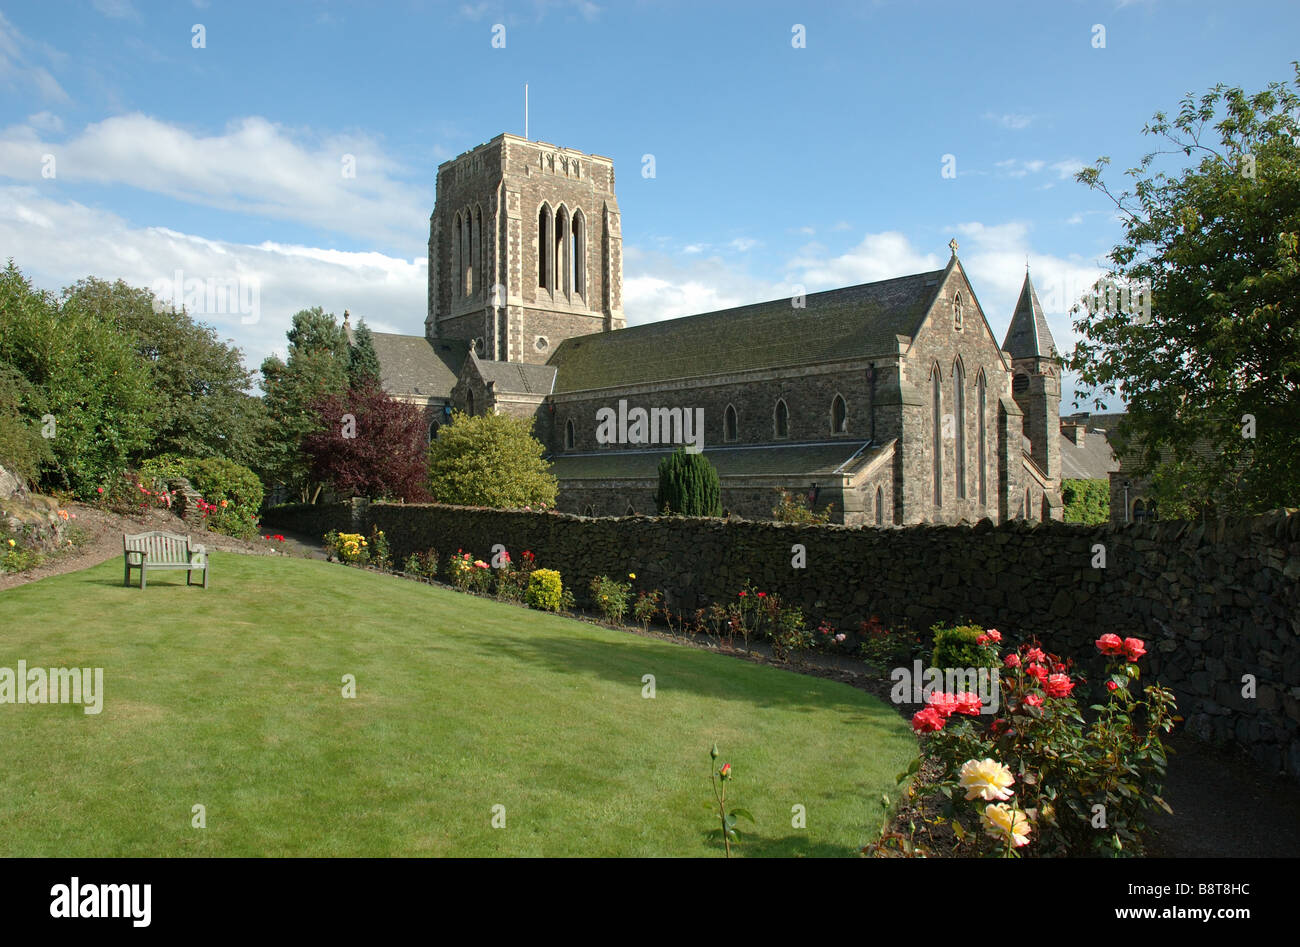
<box><xmin>547</xmin><ymin>269</ymin><xmax>945</xmax><ymax>393</ymax></box>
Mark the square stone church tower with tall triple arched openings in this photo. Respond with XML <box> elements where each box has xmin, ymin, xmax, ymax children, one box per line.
<box><xmin>425</xmin><ymin>134</ymin><xmax>625</xmax><ymax>364</ymax></box>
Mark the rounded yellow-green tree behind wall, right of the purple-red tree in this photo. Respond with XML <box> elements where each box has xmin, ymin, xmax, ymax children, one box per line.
<box><xmin>429</xmin><ymin>411</ymin><xmax>559</xmax><ymax>509</ymax></box>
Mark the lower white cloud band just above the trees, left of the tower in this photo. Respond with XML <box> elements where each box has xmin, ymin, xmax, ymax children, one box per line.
<box><xmin>0</xmin><ymin>186</ymin><xmax>428</xmax><ymax>377</ymax></box>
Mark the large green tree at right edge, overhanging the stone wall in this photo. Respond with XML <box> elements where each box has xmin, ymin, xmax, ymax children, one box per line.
<box><xmin>1067</xmin><ymin>62</ymin><xmax>1300</xmax><ymax>516</ymax></box>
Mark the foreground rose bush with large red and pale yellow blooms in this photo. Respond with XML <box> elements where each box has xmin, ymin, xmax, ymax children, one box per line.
<box><xmin>913</xmin><ymin>635</ymin><xmax>1177</xmax><ymax>856</ymax></box>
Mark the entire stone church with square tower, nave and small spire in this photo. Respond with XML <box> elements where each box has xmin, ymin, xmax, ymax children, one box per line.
<box><xmin>374</xmin><ymin>134</ymin><xmax>1062</xmax><ymax>526</ymax></box>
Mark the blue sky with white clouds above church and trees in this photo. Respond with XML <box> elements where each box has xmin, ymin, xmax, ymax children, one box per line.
<box><xmin>0</xmin><ymin>0</ymin><xmax>1300</xmax><ymax>405</ymax></box>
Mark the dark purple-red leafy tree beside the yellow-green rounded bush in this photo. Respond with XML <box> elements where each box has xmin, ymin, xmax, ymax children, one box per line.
<box><xmin>303</xmin><ymin>380</ymin><xmax>429</xmax><ymax>502</ymax></box>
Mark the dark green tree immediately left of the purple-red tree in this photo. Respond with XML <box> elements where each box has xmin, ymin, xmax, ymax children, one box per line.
<box><xmin>261</xmin><ymin>306</ymin><xmax>351</xmax><ymax>502</ymax></box>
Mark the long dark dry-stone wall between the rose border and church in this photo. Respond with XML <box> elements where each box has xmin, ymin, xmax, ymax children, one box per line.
<box><xmin>267</xmin><ymin>501</ymin><xmax>1300</xmax><ymax>778</ymax></box>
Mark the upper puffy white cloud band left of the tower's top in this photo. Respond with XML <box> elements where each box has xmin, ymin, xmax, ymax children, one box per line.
<box><xmin>0</xmin><ymin>113</ymin><xmax>433</xmax><ymax>255</ymax></box>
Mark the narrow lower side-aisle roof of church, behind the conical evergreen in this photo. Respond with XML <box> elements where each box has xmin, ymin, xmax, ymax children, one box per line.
<box><xmin>550</xmin><ymin>441</ymin><xmax>892</xmax><ymax>481</ymax></box>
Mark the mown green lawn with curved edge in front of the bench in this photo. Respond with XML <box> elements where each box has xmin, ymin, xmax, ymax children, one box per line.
<box><xmin>0</xmin><ymin>554</ymin><xmax>915</xmax><ymax>856</ymax></box>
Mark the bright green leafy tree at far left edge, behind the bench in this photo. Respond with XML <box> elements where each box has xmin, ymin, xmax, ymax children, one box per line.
<box><xmin>0</xmin><ymin>260</ymin><xmax>157</xmax><ymax>498</ymax></box>
